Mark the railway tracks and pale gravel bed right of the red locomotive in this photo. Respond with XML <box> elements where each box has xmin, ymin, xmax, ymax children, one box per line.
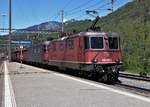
<box><xmin>115</xmin><ymin>73</ymin><xmax>150</xmax><ymax>97</ymax></box>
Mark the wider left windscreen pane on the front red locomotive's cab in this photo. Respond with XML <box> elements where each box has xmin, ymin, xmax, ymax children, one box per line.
<box><xmin>91</xmin><ymin>37</ymin><xmax>103</xmax><ymax>49</ymax></box>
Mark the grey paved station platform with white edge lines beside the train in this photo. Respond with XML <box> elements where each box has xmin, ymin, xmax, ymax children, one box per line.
<box><xmin>0</xmin><ymin>61</ymin><xmax>150</xmax><ymax>107</ymax></box>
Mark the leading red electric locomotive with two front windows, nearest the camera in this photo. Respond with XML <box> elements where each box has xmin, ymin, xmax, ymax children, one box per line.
<box><xmin>49</xmin><ymin>32</ymin><xmax>123</xmax><ymax>81</ymax></box>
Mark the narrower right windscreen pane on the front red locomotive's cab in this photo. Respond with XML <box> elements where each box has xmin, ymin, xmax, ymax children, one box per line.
<box><xmin>109</xmin><ymin>37</ymin><xmax>118</xmax><ymax>49</ymax></box>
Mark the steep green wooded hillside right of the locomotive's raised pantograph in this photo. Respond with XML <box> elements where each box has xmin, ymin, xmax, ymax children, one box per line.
<box><xmin>100</xmin><ymin>0</ymin><xmax>150</xmax><ymax>72</ymax></box>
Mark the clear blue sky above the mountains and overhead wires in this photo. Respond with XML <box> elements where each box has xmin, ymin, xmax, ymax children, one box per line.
<box><xmin>0</xmin><ymin>0</ymin><xmax>131</xmax><ymax>33</ymax></box>
